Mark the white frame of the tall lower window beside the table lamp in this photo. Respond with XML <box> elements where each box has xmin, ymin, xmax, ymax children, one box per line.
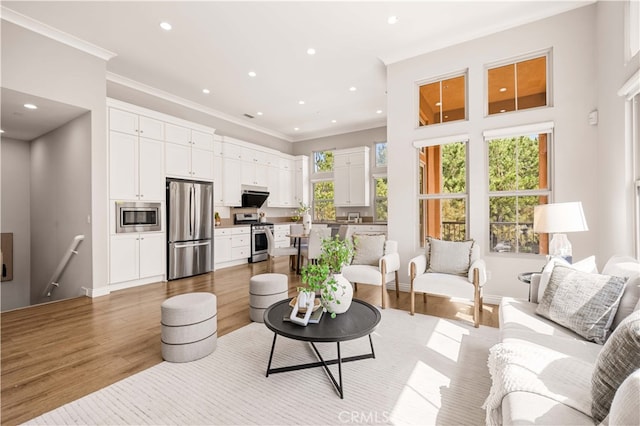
<box><xmin>483</xmin><ymin>122</ymin><xmax>555</xmax><ymax>257</ymax></box>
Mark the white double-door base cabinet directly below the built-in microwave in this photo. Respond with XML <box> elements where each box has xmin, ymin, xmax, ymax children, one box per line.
<box><xmin>109</xmin><ymin>233</ymin><xmax>166</xmax><ymax>284</ymax></box>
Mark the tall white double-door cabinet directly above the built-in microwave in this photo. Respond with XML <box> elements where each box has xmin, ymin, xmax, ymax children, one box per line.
<box><xmin>109</xmin><ymin>131</ymin><xmax>165</xmax><ymax>201</ymax></box>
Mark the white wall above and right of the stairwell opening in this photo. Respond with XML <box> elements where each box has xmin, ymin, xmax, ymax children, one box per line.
<box><xmin>0</xmin><ymin>21</ymin><xmax>109</xmax><ymax>293</ymax></box>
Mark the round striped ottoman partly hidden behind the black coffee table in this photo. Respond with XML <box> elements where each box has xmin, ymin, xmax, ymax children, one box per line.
<box><xmin>249</xmin><ymin>274</ymin><xmax>289</xmax><ymax>322</ymax></box>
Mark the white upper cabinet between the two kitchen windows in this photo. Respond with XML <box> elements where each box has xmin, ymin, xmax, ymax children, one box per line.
<box><xmin>333</xmin><ymin>146</ymin><xmax>371</xmax><ymax>207</ymax></box>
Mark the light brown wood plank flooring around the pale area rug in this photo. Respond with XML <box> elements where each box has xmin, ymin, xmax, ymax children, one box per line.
<box><xmin>0</xmin><ymin>259</ymin><xmax>498</xmax><ymax>425</ymax></box>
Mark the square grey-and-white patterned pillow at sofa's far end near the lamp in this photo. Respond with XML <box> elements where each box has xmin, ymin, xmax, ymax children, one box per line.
<box><xmin>536</xmin><ymin>265</ymin><xmax>625</xmax><ymax>344</ymax></box>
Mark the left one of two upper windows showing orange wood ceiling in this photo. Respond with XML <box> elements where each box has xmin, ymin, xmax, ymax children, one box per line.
<box><xmin>418</xmin><ymin>72</ymin><xmax>467</xmax><ymax>126</ymax></box>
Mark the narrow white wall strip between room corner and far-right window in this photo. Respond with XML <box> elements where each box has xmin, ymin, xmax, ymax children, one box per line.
<box><xmin>594</xmin><ymin>1</ymin><xmax>640</xmax><ymax>266</ymax></box>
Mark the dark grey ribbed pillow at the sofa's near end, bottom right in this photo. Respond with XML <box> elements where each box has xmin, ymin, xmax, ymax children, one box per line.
<box><xmin>591</xmin><ymin>311</ymin><xmax>640</xmax><ymax>424</ymax></box>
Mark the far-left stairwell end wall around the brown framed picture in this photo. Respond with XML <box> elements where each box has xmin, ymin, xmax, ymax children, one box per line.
<box><xmin>0</xmin><ymin>138</ymin><xmax>31</xmax><ymax>311</ymax></box>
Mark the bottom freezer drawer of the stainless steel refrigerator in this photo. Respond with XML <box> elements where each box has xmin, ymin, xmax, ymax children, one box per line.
<box><xmin>167</xmin><ymin>240</ymin><xmax>211</xmax><ymax>280</ymax></box>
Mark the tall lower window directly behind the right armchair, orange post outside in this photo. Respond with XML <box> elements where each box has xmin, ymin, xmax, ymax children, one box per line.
<box><xmin>414</xmin><ymin>136</ymin><xmax>468</xmax><ymax>247</ymax></box>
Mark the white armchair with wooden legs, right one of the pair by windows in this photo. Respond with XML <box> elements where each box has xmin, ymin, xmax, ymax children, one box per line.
<box><xmin>409</xmin><ymin>237</ymin><xmax>487</xmax><ymax>328</ymax></box>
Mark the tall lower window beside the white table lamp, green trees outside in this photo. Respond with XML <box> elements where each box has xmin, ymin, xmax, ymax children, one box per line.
<box><xmin>485</xmin><ymin>123</ymin><xmax>552</xmax><ymax>254</ymax></box>
